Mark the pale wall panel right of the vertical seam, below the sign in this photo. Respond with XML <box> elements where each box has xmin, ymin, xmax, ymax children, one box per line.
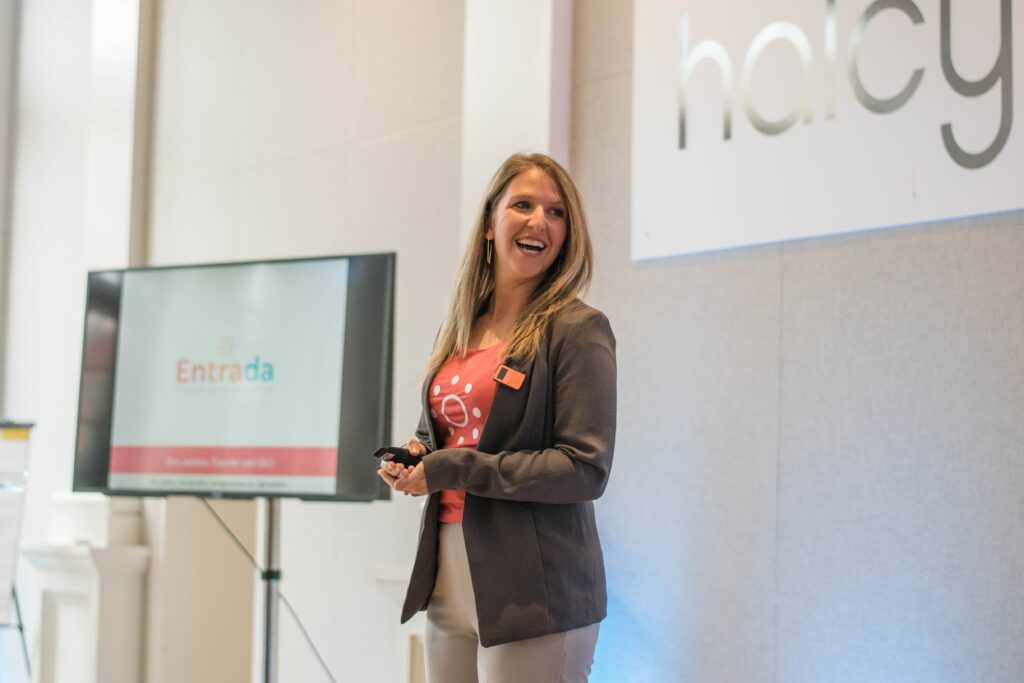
<box><xmin>777</xmin><ymin>214</ymin><xmax>1024</xmax><ymax>683</ymax></box>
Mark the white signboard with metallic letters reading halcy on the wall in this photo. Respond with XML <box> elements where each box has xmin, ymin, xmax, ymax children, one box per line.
<box><xmin>632</xmin><ymin>0</ymin><xmax>1024</xmax><ymax>259</ymax></box>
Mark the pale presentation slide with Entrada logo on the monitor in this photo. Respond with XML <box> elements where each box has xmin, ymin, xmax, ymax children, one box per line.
<box><xmin>108</xmin><ymin>259</ymin><xmax>348</xmax><ymax>496</ymax></box>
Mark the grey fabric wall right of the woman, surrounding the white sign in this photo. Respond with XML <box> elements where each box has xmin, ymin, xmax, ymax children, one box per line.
<box><xmin>571</xmin><ymin>0</ymin><xmax>1024</xmax><ymax>683</ymax></box>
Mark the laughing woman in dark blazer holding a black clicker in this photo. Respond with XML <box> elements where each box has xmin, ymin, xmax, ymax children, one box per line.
<box><xmin>380</xmin><ymin>155</ymin><xmax>615</xmax><ymax>683</ymax></box>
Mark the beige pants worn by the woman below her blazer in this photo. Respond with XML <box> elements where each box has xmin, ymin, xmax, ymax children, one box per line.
<box><xmin>426</xmin><ymin>524</ymin><xmax>599</xmax><ymax>683</ymax></box>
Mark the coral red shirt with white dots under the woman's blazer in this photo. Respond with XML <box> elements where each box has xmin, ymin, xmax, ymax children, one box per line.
<box><xmin>429</xmin><ymin>342</ymin><xmax>505</xmax><ymax>523</ymax></box>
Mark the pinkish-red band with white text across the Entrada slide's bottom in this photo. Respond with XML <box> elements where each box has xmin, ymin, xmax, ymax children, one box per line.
<box><xmin>110</xmin><ymin>445</ymin><xmax>338</xmax><ymax>477</ymax></box>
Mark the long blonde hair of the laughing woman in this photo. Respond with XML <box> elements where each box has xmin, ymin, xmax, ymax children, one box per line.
<box><xmin>425</xmin><ymin>154</ymin><xmax>594</xmax><ymax>379</ymax></box>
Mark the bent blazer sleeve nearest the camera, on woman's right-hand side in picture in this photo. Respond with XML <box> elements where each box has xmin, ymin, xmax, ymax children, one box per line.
<box><xmin>424</xmin><ymin>309</ymin><xmax>616</xmax><ymax>503</ymax></box>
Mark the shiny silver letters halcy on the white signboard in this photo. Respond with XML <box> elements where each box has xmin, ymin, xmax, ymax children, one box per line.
<box><xmin>679</xmin><ymin>0</ymin><xmax>1014</xmax><ymax>169</ymax></box>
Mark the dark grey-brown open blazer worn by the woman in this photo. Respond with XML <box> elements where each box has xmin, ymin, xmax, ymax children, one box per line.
<box><xmin>401</xmin><ymin>300</ymin><xmax>615</xmax><ymax>647</ymax></box>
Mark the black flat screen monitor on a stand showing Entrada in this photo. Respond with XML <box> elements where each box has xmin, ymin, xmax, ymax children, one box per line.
<box><xmin>73</xmin><ymin>254</ymin><xmax>394</xmax><ymax>501</ymax></box>
